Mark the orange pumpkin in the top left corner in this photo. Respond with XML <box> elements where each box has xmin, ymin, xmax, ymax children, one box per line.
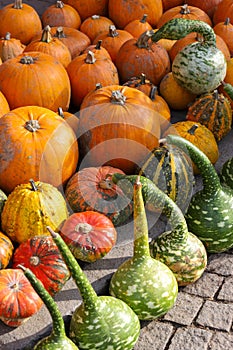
<box><xmin>0</xmin><ymin>0</ymin><xmax>42</xmax><ymax>45</ymax></box>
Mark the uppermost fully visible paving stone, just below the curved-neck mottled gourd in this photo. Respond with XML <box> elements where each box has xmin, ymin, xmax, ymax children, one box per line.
<box><xmin>183</xmin><ymin>273</ymin><xmax>224</xmax><ymax>298</ymax></box>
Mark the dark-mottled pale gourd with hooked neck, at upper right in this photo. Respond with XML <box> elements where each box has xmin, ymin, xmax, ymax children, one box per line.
<box><xmin>151</xmin><ymin>18</ymin><xmax>226</xmax><ymax>95</ymax></box>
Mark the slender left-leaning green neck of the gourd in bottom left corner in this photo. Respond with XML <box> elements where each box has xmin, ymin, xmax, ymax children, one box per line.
<box><xmin>17</xmin><ymin>264</ymin><xmax>66</xmax><ymax>338</ymax></box>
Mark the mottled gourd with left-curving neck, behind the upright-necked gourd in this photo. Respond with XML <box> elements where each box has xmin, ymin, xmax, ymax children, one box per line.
<box><xmin>113</xmin><ymin>174</ymin><xmax>207</xmax><ymax>286</ymax></box>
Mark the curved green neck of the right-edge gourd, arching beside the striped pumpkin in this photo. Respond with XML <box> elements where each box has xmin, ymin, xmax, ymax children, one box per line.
<box><xmin>166</xmin><ymin>134</ymin><xmax>222</xmax><ymax>198</ymax></box>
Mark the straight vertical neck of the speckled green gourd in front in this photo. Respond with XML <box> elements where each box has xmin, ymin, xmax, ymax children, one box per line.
<box><xmin>133</xmin><ymin>176</ymin><xmax>150</xmax><ymax>259</ymax></box>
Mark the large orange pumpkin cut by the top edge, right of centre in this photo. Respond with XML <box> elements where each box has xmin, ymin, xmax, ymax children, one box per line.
<box><xmin>108</xmin><ymin>0</ymin><xmax>163</xmax><ymax>29</ymax></box>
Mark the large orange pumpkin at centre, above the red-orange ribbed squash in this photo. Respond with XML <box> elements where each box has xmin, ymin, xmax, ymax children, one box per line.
<box><xmin>79</xmin><ymin>85</ymin><xmax>160</xmax><ymax>174</ymax></box>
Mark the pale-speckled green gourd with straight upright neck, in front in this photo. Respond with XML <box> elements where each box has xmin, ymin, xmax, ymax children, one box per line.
<box><xmin>109</xmin><ymin>175</ymin><xmax>178</xmax><ymax>320</ymax></box>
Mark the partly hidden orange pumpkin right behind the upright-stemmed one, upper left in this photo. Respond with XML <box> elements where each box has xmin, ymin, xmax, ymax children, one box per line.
<box><xmin>51</xmin><ymin>27</ymin><xmax>91</xmax><ymax>59</ymax></box>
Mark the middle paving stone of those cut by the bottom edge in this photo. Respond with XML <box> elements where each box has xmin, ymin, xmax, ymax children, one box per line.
<box><xmin>168</xmin><ymin>327</ymin><xmax>212</xmax><ymax>350</ymax></box>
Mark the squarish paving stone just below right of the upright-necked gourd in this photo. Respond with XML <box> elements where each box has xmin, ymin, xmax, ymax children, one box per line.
<box><xmin>164</xmin><ymin>292</ymin><xmax>203</xmax><ymax>325</ymax></box>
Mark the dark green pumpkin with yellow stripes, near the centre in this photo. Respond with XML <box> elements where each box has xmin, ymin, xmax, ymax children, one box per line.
<box><xmin>137</xmin><ymin>145</ymin><xmax>194</xmax><ymax>212</ymax></box>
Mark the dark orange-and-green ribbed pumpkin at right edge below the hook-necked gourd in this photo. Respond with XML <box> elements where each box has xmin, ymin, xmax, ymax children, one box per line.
<box><xmin>186</xmin><ymin>90</ymin><xmax>232</xmax><ymax>141</ymax></box>
